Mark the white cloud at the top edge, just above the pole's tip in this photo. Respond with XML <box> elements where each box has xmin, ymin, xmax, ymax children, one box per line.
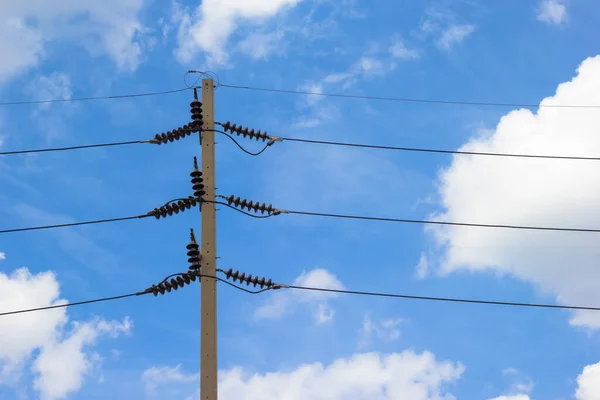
<box><xmin>175</xmin><ymin>0</ymin><xmax>302</xmax><ymax>65</ymax></box>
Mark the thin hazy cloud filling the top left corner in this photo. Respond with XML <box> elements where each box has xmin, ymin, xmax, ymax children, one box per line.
<box><xmin>0</xmin><ymin>0</ymin><xmax>144</xmax><ymax>83</ymax></box>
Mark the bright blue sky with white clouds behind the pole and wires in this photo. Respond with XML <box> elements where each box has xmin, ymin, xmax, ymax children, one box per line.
<box><xmin>0</xmin><ymin>0</ymin><xmax>600</xmax><ymax>400</ymax></box>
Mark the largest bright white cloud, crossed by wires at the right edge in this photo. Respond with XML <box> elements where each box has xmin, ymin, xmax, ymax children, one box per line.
<box><xmin>431</xmin><ymin>56</ymin><xmax>600</xmax><ymax>328</ymax></box>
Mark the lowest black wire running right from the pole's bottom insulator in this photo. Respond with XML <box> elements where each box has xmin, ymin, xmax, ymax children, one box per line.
<box><xmin>281</xmin><ymin>285</ymin><xmax>600</xmax><ymax>311</ymax></box>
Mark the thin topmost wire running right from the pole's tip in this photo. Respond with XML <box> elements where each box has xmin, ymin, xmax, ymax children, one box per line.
<box><xmin>219</xmin><ymin>83</ymin><xmax>600</xmax><ymax>108</ymax></box>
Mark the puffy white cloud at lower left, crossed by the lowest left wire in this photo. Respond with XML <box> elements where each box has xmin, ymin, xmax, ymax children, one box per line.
<box><xmin>0</xmin><ymin>268</ymin><xmax>132</xmax><ymax>400</ymax></box>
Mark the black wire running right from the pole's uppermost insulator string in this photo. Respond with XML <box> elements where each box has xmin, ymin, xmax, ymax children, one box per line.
<box><xmin>281</xmin><ymin>137</ymin><xmax>600</xmax><ymax>161</ymax></box>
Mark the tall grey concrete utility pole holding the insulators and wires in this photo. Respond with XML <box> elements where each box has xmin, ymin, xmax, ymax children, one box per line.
<box><xmin>200</xmin><ymin>79</ymin><xmax>217</xmax><ymax>400</ymax></box>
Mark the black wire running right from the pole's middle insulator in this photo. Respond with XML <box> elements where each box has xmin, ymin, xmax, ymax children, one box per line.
<box><xmin>284</xmin><ymin>210</ymin><xmax>600</xmax><ymax>233</ymax></box>
